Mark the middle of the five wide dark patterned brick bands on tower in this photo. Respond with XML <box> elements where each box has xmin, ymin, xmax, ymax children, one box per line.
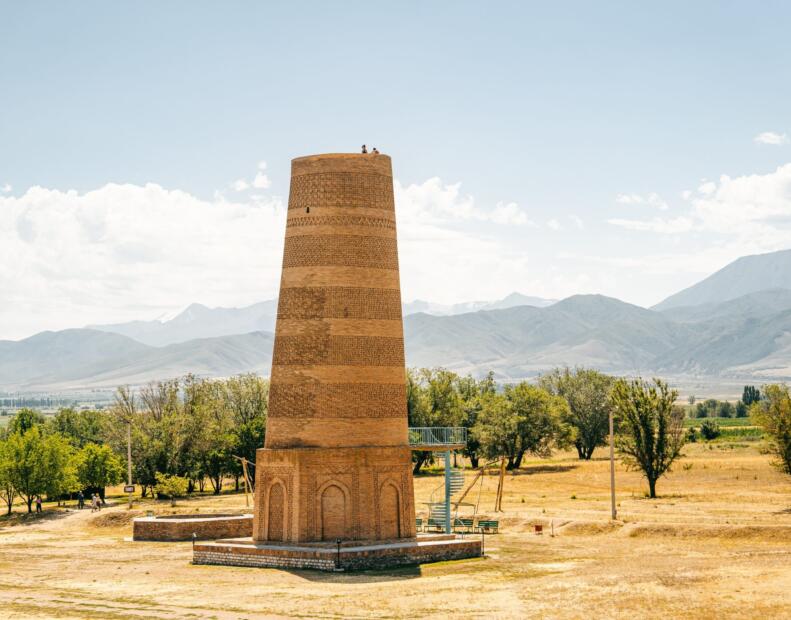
<box><xmin>277</xmin><ymin>286</ymin><xmax>401</xmax><ymax>320</ymax></box>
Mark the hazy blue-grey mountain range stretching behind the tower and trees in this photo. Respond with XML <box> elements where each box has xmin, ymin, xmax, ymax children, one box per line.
<box><xmin>0</xmin><ymin>251</ymin><xmax>791</xmax><ymax>391</ymax></box>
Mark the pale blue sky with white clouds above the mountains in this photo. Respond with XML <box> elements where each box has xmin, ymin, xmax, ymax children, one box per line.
<box><xmin>0</xmin><ymin>0</ymin><xmax>791</xmax><ymax>339</ymax></box>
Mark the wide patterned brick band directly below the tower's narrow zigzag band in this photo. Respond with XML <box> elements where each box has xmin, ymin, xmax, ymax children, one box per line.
<box><xmin>283</xmin><ymin>235</ymin><xmax>398</xmax><ymax>269</ymax></box>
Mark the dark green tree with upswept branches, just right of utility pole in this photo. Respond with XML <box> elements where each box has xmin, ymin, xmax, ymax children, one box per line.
<box><xmin>612</xmin><ymin>379</ymin><xmax>685</xmax><ymax>498</ymax></box>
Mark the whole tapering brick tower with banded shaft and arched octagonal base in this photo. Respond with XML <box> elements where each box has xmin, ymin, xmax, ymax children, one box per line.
<box><xmin>253</xmin><ymin>154</ymin><xmax>415</xmax><ymax>543</ymax></box>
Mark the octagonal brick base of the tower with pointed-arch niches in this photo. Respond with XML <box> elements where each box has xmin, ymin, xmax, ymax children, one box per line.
<box><xmin>253</xmin><ymin>446</ymin><xmax>416</xmax><ymax>544</ymax></box>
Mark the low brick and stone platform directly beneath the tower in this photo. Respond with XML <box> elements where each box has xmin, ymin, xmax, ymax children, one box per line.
<box><xmin>192</xmin><ymin>534</ymin><xmax>481</xmax><ymax>571</ymax></box>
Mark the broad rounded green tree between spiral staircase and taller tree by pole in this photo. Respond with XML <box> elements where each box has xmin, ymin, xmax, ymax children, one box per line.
<box><xmin>474</xmin><ymin>382</ymin><xmax>572</xmax><ymax>470</ymax></box>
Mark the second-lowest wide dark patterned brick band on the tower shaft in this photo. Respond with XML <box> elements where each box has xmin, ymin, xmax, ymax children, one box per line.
<box><xmin>272</xmin><ymin>335</ymin><xmax>404</xmax><ymax>366</ymax></box>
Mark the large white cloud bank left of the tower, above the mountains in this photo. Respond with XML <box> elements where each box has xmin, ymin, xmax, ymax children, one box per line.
<box><xmin>0</xmin><ymin>183</ymin><xmax>285</xmax><ymax>338</ymax></box>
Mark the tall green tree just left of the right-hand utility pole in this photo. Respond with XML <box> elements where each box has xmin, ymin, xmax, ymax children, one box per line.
<box><xmin>539</xmin><ymin>368</ymin><xmax>614</xmax><ymax>460</ymax></box>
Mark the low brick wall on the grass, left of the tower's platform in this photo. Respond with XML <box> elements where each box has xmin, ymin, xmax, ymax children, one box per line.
<box><xmin>132</xmin><ymin>514</ymin><xmax>253</xmax><ymax>542</ymax></box>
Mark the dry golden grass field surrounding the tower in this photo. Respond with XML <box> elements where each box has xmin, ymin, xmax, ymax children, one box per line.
<box><xmin>0</xmin><ymin>443</ymin><xmax>791</xmax><ymax>619</ymax></box>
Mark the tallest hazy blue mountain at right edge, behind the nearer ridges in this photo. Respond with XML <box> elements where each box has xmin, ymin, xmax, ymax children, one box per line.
<box><xmin>653</xmin><ymin>250</ymin><xmax>791</xmax><ymax>310</ymax></box>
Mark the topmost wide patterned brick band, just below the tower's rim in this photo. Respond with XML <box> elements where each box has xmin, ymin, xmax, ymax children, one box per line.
<box><xmin>288</xmin><ymin>172</ymin><xmax>394</xmax><ymax>210</ymax></box>
